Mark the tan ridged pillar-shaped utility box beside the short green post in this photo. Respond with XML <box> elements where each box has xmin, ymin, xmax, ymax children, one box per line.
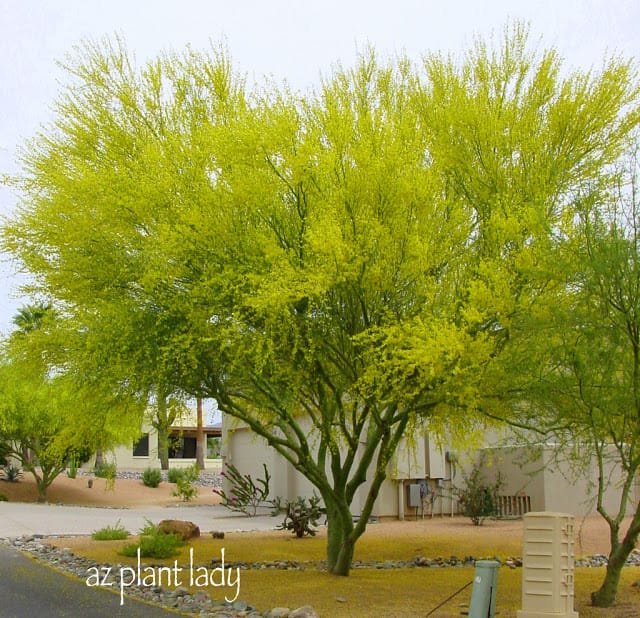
<box><xmin>518</xmin><ymin>512</ymin><xmax>578</xmax><ymax>618</ymax></box>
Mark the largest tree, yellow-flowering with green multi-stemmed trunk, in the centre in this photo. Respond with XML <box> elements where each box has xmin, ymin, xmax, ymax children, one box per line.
<box><xmin>3</xmin><ymin>28</ymin><xmax>635</xmax><ymax>575</ymax></box>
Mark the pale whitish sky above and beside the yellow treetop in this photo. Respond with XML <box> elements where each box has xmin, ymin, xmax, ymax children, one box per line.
<box><xmin>0</xmin><ymin>0</ymin><xmax>640</xmax><ymax>334</ymax></box>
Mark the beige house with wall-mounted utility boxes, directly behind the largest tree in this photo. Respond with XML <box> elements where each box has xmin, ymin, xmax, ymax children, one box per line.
<box><xmin>222</xmin><ymin>417</ymin><xmax>640</xmax><ymax>519</ymax></box>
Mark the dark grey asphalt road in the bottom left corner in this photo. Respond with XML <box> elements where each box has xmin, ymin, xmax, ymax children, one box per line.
<box><xmin>0</xmin><ymin>545</ymin><xmax>176</xmax><ymax>618</ymax></box>
